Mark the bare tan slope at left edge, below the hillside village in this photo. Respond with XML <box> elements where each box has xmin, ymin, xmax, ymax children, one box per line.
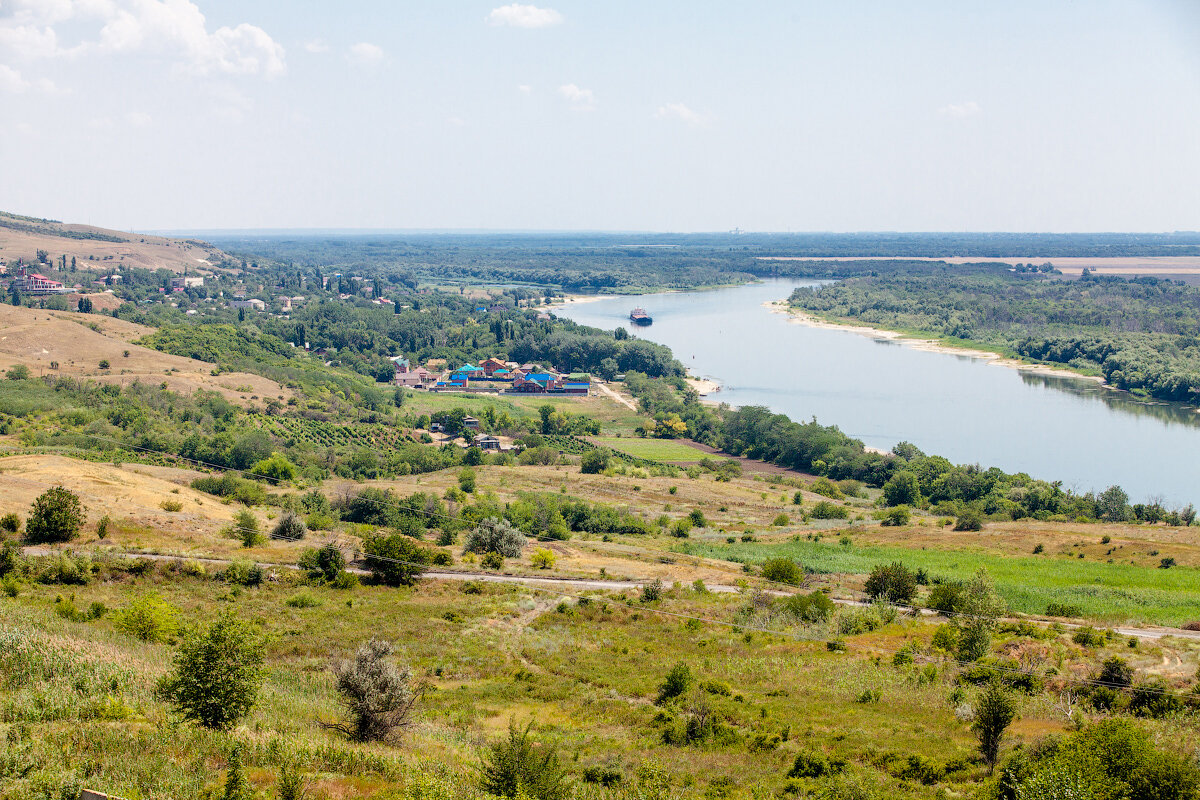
<box><xmin>0</xmin><ymin>305</ymin><xmax>292</xmax><ymax>407</ymax></box>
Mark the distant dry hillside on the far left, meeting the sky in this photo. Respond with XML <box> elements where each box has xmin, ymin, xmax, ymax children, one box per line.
<box><xmin>0</xmin><ymin>211</ymin><xmax>226</xmax><ymax>272</ymax></box>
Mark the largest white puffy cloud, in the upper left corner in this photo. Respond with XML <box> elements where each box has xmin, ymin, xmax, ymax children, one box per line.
<box><xmin>0</xmin><ymin>0</ymin><xmax>287</xmax><ymax>78</ymax></box>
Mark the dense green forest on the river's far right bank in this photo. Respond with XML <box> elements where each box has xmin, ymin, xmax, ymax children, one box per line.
<box><xmin>791</xmin><ymin>266</ymin><xmax>1200</xmax><ymax>403</ymax></box>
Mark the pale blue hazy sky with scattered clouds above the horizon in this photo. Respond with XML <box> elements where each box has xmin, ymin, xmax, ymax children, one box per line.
<box><xmin>0</xmin><ymin>0</ymin><xmax>1200</xmax><ymax>231</ymax></box>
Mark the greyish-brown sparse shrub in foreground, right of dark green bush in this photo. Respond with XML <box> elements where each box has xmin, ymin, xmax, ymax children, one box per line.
<box><xmin>323</xmin><ymin>639</ymin><xmax>424</xmax><ymax>741</ymax></box>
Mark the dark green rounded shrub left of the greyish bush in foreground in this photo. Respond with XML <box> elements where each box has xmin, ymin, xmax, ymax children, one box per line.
<box><xmin>157</xmin><ymin>612</ymin><xmax>264</xmax><ymax>730</ymax></box>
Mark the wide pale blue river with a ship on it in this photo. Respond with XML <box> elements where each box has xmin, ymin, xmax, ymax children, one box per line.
<box><xmin>556</xmin><ymin>279</ymin><xmax>1200</xmax><ymax>506</ymax></box>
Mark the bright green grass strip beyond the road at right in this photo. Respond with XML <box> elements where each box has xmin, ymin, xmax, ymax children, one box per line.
<box><xmin>676</xmin><ymin>537</ymin><xmax>1200</xmax><ymax>626</ymax></box>
